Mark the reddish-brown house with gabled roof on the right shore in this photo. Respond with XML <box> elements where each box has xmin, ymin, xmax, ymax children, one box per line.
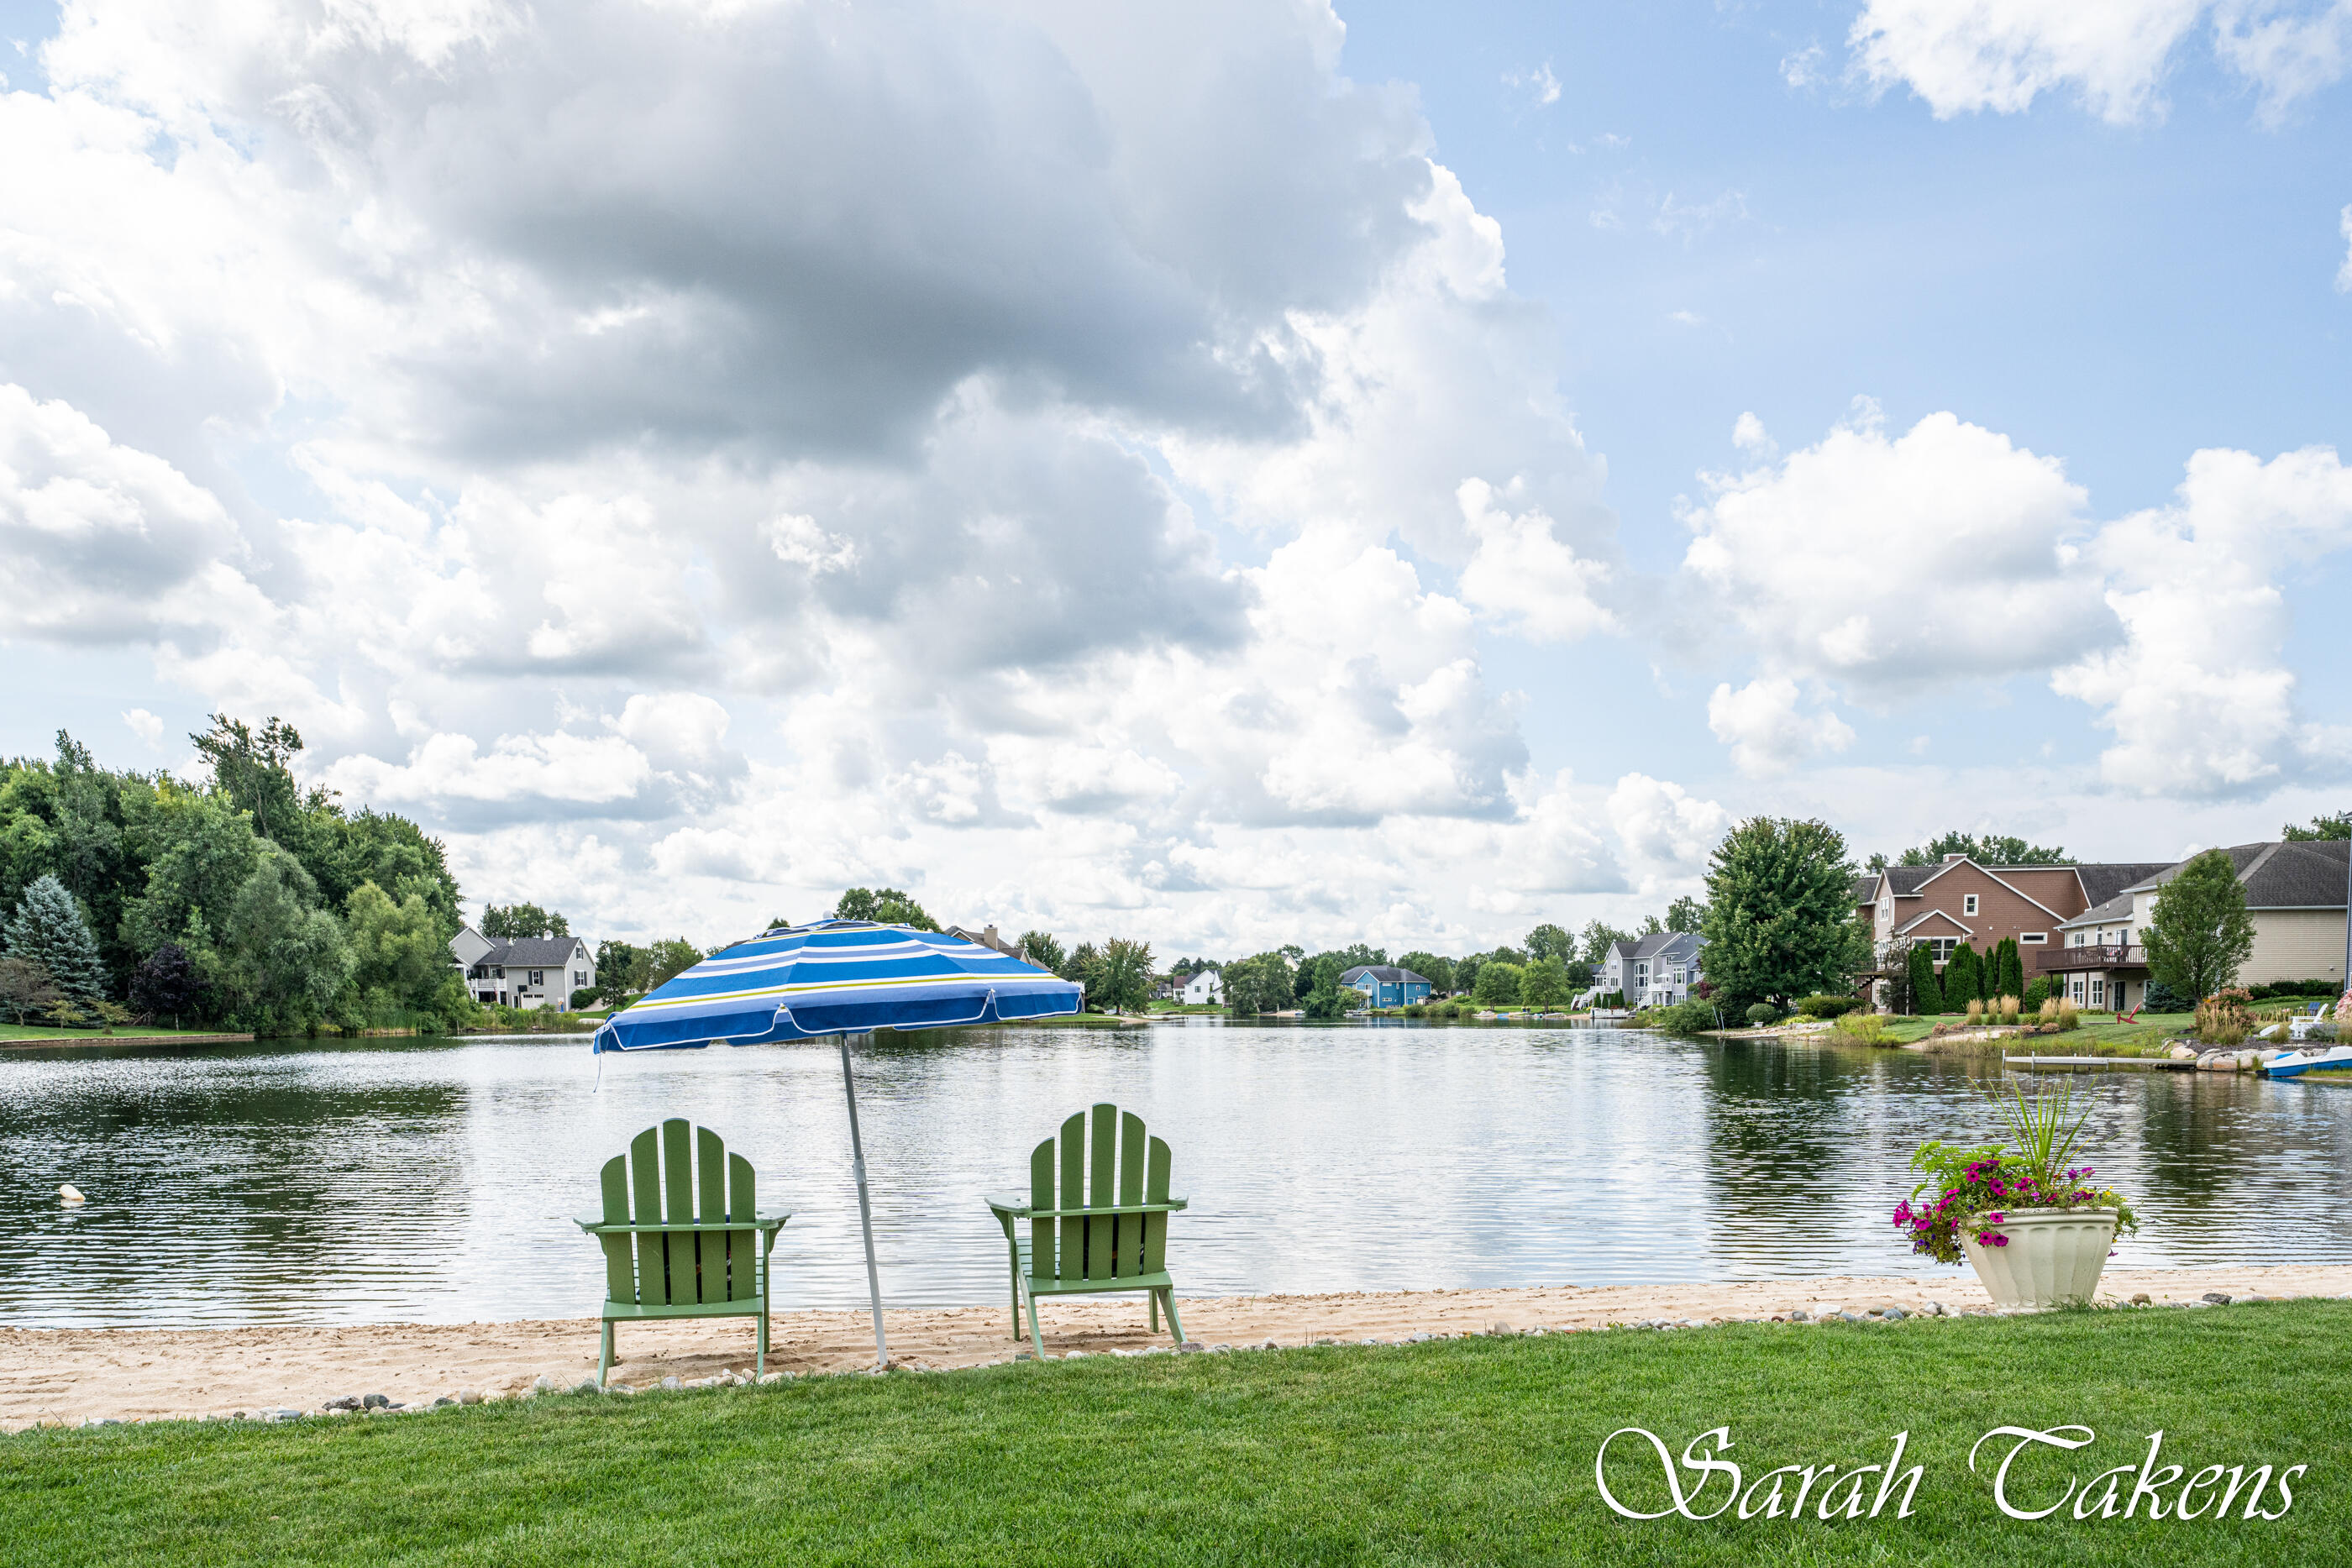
<box><xmin>1856</xmin><ymin>856</ymin><xmax>2169</xmax><ymax>978</ymax></box>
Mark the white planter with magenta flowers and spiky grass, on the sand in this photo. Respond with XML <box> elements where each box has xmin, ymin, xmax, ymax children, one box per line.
<box><xmin>1896</xmin><ymin>1083</ymin><xmax>2140</xmax><ymax>1307</ymax></box>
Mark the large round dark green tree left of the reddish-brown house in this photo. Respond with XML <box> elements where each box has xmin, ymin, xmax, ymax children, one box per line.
<box><xmin>1703</xmin><ymin>815</ymin><xmax>1870</xmax><ymax>1009</ymax></box>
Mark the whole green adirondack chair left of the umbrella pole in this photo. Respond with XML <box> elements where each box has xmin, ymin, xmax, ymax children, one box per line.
<box><xmin>576</xmin><ymin>1117</ymin><xmax>790</xmax><ymax>1387</ymax></box>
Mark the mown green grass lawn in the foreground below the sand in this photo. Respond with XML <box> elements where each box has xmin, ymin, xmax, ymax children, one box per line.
<box><xmin>0</xmin><ymin>1303</ymin><xmax>2352</xmax><ymax>1568</ymax></box>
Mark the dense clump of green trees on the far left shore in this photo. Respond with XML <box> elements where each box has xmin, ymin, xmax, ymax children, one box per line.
<box><xmin>0</xmin><ymin>715</ymin><xmax>473</xmax><ymax>1035</ymax></box>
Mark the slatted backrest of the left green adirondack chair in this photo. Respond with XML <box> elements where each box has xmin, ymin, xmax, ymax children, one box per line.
<box><xmin>600</xmin><ymin>1117</ymin><xmax>759</xmax><ymax>1307</ymax></box>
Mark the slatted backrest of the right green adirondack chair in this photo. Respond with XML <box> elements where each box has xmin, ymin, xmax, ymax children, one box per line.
<box><xmin>1030</xmin><ymin>1105</ymin><xmax>1173</xmax><ymax>1279</ymax></box>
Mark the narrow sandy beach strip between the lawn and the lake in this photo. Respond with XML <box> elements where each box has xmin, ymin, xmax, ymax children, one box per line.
<box><xmin>0</xmin><ymin>1265</ymin><xmax>2352</xmax><ymax>1429</ymax></box>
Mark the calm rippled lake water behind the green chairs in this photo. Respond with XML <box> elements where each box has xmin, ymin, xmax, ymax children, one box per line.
<box><xmin>0</xmin><ymin>1018</ymin><xmax>2352</xmax><ymax>1326</ymax></box>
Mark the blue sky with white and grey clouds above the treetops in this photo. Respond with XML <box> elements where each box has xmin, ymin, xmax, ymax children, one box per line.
<box><xmin>0</xmin><ymin>0</ymin><xmax>2352</xmax><ymax>954</ymax></box>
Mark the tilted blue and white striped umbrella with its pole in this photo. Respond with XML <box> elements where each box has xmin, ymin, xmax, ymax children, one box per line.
<box><xmin>591</xmin><ymin>919</ymin><xmax>1084</xmax><ymax>1366</ymax></box>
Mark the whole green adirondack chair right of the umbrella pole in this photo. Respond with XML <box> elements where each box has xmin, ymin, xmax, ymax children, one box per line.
<box><xmin>988</xmin><ymin>1105</ymin><xmax>1185</xmax><ymax>1361</ymax></box>
